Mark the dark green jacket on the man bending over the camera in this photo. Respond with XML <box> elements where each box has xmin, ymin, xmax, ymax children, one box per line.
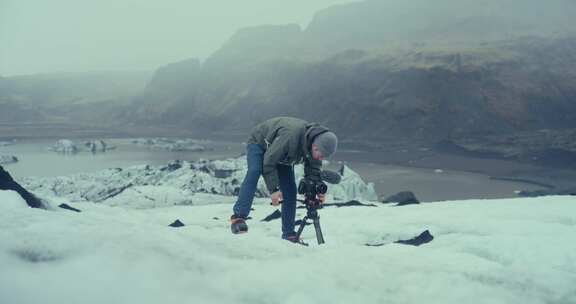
<box><xmin>248</xmin><ymin>117</ymin><xmax>329</xmax><ymax>193</ymax></box>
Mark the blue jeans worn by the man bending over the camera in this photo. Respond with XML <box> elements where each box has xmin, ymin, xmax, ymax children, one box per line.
<box><xmin>233</xmin><ymin>144</ymin><xmax>297</xmax><ymax>237</ymax></box>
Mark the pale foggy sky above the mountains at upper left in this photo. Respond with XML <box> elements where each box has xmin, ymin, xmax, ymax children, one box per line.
<box><xmin>0</xmin><ymin>0</ymin><xmax>352</xmax><ymax>76</ymax></box>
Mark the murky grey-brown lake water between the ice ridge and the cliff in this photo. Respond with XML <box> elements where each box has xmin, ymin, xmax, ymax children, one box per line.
<box><xmin>0</xmin><ymin>139</ymin><xmax>541</xmax><ymax>201</ymax></box>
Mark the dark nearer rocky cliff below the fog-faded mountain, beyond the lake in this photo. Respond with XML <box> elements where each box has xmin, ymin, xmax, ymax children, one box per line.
<box><xmin>131</xmin><ymin>38</ymin><xmax>576</xmax><ymax>141</ymax></box>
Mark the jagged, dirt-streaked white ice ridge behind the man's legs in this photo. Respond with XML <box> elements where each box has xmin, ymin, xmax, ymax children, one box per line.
<box><xmin>20</xmin><ymin>157</ymin><xmax>377</xmax><ymax>208</ymax></box>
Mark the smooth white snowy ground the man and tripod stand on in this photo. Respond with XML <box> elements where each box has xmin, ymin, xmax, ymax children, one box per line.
<box><xmin>0</xmin><ymin>188</ymin><xmax>576</xmax><ymax>304</ymax></box>
